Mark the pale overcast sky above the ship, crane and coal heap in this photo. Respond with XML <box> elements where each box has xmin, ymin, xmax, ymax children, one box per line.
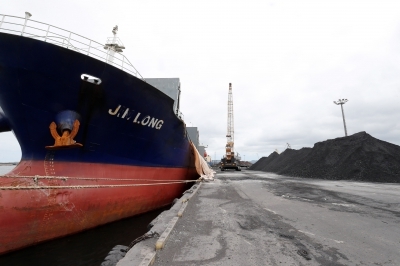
<box><xmin>0</xmin><ymin>0</ymin><xmax>400</xmax><ymax>162</ymax></box>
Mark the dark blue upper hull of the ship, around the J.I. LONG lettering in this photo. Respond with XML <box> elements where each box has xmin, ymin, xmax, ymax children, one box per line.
<box><xmin>0</xmin><ymin>33</ymin><xmax>192</xmax><ymax>167</ymax></box>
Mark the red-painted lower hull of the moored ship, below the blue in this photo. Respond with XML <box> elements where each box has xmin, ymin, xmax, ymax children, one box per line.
<box><xmin>0</xmin><ymin>161</ymin><xmax>198</xmax><ymax>254</ymax></box>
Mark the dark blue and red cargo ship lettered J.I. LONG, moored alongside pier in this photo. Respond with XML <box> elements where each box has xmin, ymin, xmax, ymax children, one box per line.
<box><xmin>0</xmin><ymin>13</ymin><xmax>199</xmax><ymax>254</ymax></box>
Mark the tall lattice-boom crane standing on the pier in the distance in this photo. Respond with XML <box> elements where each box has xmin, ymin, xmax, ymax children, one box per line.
<box><xmin>220</xmin><ymin>83</ymin><xmax>240</xmax><ymax>171</ymax></box>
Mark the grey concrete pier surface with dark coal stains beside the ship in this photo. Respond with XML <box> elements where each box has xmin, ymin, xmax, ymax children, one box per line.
<box><xmin>118</xmin><ymin>170</ymin><xmax>400</xmax><ymax>266</ymax></box>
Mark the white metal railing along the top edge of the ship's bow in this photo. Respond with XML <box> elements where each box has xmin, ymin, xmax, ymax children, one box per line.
<box><xmin>0</xmin><ymin>14</ymin><xmax>144</xmax><ymax>80</ymax></box>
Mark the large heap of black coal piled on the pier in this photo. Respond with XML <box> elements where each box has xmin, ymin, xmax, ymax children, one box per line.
<box><xmin>249</xmin><ymin>132</ymin><xmax>400</xmax><ymax>183</ymax></box>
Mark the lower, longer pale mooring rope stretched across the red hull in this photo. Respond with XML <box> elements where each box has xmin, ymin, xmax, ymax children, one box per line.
<box><xmin>0</xmin><ymin>180</ymin><xmax>197</xmax><ymax>190</ymax></box>
